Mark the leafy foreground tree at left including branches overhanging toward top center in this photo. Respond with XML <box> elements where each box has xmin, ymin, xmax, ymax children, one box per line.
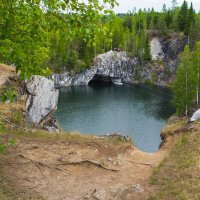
<box><xmin>0</xmin><ymin>0</ymin><xmax>116</xmax><ymax>79</ymax></box>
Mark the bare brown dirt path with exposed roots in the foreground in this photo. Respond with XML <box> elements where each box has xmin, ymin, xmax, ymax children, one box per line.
<box><xmin>0</xmin><ymin>136</ymin><xmax>169</xmax><ymax>200</ymax></box>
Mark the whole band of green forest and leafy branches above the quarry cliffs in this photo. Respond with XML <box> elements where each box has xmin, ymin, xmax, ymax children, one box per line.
<box><xmin>0</xmin><ymin>0</ymin><xmax>200</xmax><ymax>79</ymax></box>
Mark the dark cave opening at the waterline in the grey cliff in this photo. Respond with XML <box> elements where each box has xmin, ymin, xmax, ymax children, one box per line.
<box><xmin>88</xmin><ymin>74</ymin><xmax>112</xmax><ymax>87</ymax></box>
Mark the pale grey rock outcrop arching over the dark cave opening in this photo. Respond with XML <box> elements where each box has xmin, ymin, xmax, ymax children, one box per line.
<box><xmin>52</xmin><ymin>51</ymin><xmax>138</xmax><ymax>87</ymax></box>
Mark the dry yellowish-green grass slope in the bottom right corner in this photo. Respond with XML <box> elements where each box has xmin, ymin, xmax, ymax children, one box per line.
<box><xmin>150</xmin><ymin>132</ymin><xmax>200</xmax><ymax>200</ymax></box>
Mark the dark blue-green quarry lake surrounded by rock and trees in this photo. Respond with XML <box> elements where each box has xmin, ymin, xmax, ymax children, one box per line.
<box><xmin>56</xmin><ymin>85</ymin><xmax>174</xmax><ymax>152</ymax></box>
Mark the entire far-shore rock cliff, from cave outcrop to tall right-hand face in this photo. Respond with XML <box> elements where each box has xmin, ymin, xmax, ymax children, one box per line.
<box><xmin>52</xmin><ymin>34</ymin><xmax>187</xmax><ymax>87</ymax></box>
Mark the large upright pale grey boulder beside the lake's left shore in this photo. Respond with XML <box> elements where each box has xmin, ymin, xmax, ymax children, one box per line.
<box><xmin>26</xmin><ymin>76</ymin><xmax>59</xmax><ymax>124</ymax></box>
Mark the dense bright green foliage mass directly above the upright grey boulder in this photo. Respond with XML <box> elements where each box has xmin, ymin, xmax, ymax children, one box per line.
<box><xmin>0</xmin><ymin>0</ymin><xmax>49</xmax><ymax>79</ymax></box>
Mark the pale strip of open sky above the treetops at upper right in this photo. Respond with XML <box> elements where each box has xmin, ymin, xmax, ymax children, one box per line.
<box><xmin>114</xmin><ymin>0</ymin><xmax>200</xmax><ymax>13</ymax></box>
